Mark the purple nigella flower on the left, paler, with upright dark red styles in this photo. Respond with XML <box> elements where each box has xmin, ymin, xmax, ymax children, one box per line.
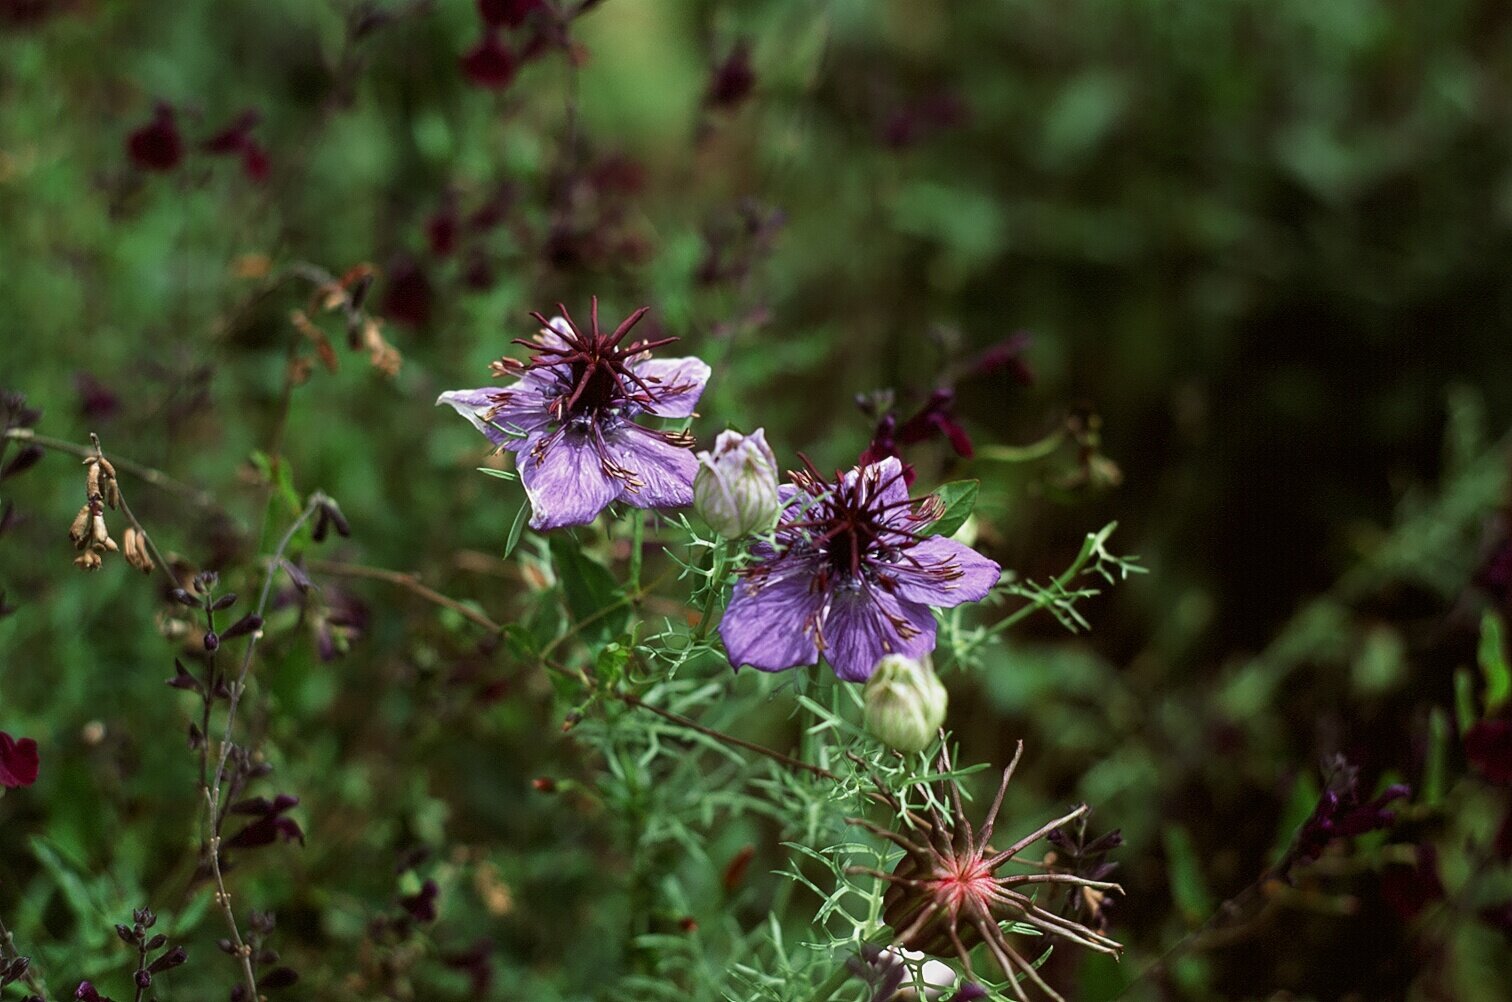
<box><xmin>437</xmin><ymin>299</ymin><xmax>709</xmax><ymax>529</ymax></box>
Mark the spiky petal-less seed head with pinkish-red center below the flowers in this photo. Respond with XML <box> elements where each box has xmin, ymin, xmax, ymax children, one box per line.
<box><xmin>847</xmin><ymin>741</ymin><xmax>1123</xmax><ymax>1002</ymax></box>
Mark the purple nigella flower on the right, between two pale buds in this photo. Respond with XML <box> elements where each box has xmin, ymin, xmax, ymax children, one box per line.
<box><xmin>720</xmin><ymin>458</ymin><xmax>999</xmax><ymax>682</ymax></box>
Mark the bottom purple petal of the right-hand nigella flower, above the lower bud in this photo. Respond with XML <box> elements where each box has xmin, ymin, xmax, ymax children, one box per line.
<box><xmin>824</xmin><ymin>585</ymin><xmax>934</xmax><ymax>682</ymax></box>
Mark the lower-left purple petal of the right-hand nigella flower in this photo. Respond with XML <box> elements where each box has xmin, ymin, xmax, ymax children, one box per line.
<box><xmin>720</xmin><ymin>567</ymin><xmax>824</xmax><ymax>671</ymax></box>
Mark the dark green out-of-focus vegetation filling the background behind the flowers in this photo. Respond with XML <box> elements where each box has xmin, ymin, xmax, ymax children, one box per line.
<box><xmin>0</xmin><ymin>0</ymin><xmax>1512</xmax><ymax>999</ymax></box>
